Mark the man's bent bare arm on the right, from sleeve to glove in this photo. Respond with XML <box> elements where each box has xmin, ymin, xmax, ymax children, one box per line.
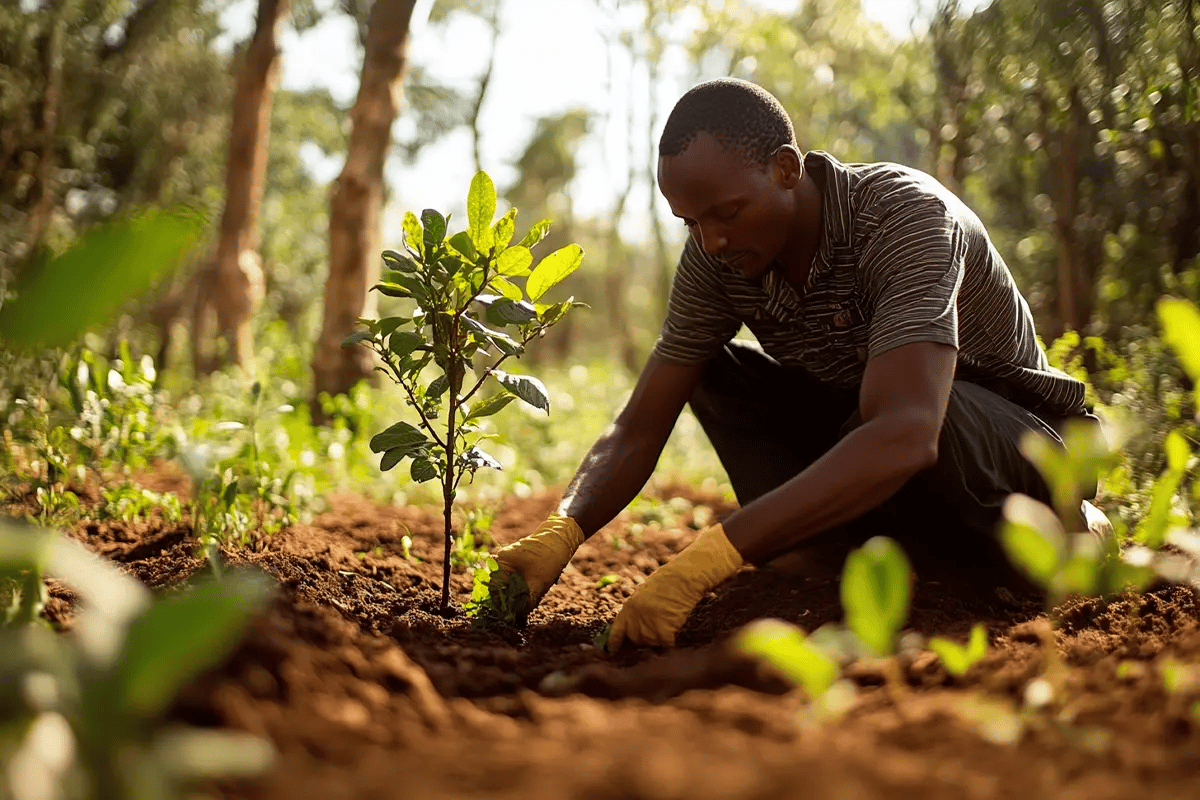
<box><xmin>724</xmin><ymin>342</ymin><xmax>956</xmax><ymax>561</ymax></box>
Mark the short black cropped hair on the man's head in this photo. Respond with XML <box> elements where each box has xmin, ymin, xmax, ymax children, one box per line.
<box><xmin>659</xmin><ymin>78</ymin><xmax>796</xmax><ymax>167</ymax></box>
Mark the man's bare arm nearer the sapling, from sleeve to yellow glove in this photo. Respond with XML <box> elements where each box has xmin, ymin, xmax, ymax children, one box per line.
<box><xmin>558</xmin><ymin>355</ymin><xmax>704</xmax><ymax>536</ymax></box>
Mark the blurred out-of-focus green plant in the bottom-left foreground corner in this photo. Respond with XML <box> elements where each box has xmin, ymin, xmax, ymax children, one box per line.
<box><xmin>0</xmin><ymin>522</ymin><xmax>274</xmax><ymax>800</ymax></box>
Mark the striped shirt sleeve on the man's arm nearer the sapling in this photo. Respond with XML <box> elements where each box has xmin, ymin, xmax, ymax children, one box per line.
<box><xmin>654</xmin><ymin>237</ymin><xmax>742</xmax><ymax>365</ymax></box>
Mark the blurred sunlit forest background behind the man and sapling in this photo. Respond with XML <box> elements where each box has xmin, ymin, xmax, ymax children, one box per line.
<box><xmin>0</xmin><ymin>0</ymin><xmax>1200</xmax><ymax>519</ymax></box>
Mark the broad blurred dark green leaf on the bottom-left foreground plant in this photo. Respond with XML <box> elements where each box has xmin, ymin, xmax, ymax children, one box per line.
<box><xmin>116</xmin><ymin>571</ymin><xmax>271</xmax><ymax>717</ymax></box>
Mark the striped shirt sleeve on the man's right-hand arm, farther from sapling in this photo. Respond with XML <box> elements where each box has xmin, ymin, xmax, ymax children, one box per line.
<box><xmin>859</xmin><ymin>194</ymin><xmax>967</xmax><ymax>357</ymax></box>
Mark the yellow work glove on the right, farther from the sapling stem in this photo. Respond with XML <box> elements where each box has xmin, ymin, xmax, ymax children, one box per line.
<box><xmin>608</xmin><ymin>524</ymin><xmax>742</xmax><ymax>652</ymax></box>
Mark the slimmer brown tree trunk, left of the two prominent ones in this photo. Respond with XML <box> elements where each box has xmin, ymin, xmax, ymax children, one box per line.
<box><xmin>192</xmin><ymin>0</ymin><xmax>292</xmax><ymax>372</ymax></box>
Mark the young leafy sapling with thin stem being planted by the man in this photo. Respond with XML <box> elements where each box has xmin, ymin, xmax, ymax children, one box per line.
<box><xmin>343</xmin><ymin>172</ymin><xmax>583</xmax><ymax>612</ymax></box>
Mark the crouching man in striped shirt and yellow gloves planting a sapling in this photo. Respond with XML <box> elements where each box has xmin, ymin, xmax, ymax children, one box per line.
<box><xmin>496</xmin><ymin>79</ymin><xmax>1094</xmax><ymax>650</ymax></box>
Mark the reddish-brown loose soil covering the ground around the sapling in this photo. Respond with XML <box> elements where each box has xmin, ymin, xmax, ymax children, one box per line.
<box><xmin>25</xmin><ymin>470</ymin><xmax>1200</xmax><ymax>800</ymax></box>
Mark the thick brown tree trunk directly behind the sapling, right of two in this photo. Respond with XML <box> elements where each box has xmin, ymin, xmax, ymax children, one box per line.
<box><xmin>312</xmin><ymin>0</ymin><xmax>416</xmax><ymax>421</ymax></box>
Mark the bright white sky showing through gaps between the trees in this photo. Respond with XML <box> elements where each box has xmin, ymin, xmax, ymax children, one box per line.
<box><xmin>224</xmin><ymin>0</ymin><xmax>983</xmax><ymax>239</ymax></box>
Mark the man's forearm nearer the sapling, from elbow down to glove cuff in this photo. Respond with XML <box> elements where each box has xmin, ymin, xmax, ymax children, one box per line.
<box><xmin>558</xmin><ymin>423</ymin><xmax>666</xmax><ymax>536</ymax></box>
